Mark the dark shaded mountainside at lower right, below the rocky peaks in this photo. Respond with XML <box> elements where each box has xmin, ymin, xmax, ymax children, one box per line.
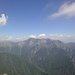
<box><xmin>32</xmin><ymin>48</ymin><xmax>75</xmax><ymax>75</ymax></box>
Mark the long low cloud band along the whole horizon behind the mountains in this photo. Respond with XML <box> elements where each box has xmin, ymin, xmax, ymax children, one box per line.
<box><xmin>0</xmin><ymin>34</ymin><xmax>75</xmax><ymax>42</ymax></box>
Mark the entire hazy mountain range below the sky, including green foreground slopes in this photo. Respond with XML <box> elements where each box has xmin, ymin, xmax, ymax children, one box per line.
<box><xmin>0</xmin><ymin>38</ymin><xmax>75</xmax><ymax>75</ymax></box>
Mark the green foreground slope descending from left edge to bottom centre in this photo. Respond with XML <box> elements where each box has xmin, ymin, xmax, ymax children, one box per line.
<box><xmin>0</xmin><ymin>53</ymin><xmax>48</xmax><ymax>75</ymax></box>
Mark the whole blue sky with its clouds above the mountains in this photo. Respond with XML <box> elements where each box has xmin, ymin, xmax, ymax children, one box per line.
<box><xmin>0</xmin><ymin>0</ymin><xmax>75</xmax><ymax>42</ymax></box>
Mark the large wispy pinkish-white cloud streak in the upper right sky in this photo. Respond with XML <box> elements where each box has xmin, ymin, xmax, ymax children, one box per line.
<box><xmin>48</xmin><ymin>2</ymin><xmax>75</xmax><ymax>18</ymax></box>
